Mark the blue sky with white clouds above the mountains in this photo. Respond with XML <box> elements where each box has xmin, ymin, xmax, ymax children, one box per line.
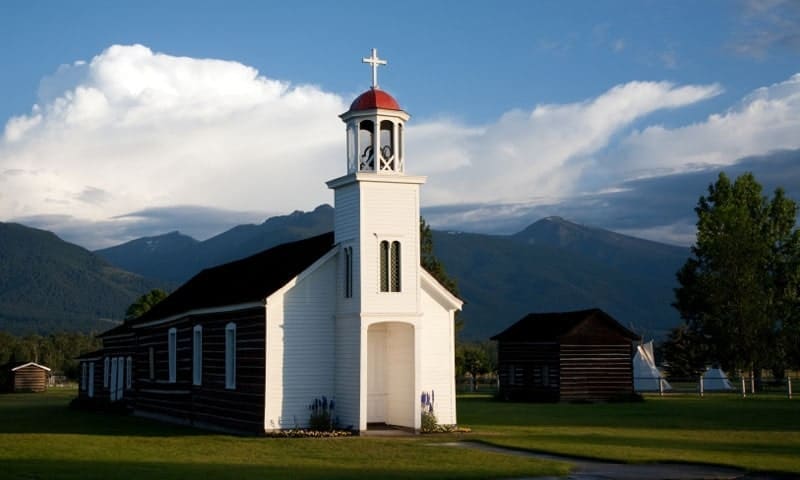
<box><xmin>0</xmin><ymin>0</ymin><xmax>800</xmax><ymax>249</ymax></box>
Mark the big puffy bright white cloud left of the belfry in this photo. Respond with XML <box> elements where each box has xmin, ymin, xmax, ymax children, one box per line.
<box><xmin>0</xmin><ymin>45</ymin><xmax>346</xmax><ymax>232</ymax></box>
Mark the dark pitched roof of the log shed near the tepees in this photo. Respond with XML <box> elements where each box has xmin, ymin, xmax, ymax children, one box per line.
<box><xmin>492</xmin><ymin>308</ymin><xmax>639</xmax><ymax>342</ymax></box>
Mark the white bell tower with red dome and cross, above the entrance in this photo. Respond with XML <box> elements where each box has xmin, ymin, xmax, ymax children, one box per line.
<box><xmin>327</xmin><ymin>49</ymin><xmax>425</xmax><ymax>318</ymax></box>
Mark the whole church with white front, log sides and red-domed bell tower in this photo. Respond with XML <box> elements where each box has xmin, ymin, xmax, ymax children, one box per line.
<box><xmin>80</xmin><ymin>49</ymin><xmax>462</xmax><ymax>434</ymax></box>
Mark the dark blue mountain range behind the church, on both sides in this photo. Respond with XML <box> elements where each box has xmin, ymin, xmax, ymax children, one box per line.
<box><xmin>0</xmin><ymin>205</ymin><xmax>689</xmax><ymax>340</ymax></box>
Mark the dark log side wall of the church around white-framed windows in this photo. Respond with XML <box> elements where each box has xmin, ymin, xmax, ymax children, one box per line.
<box><xmin>134</xmin><ymin>308</ymin><xmax>266</xmax><ymax>433</ymax></box>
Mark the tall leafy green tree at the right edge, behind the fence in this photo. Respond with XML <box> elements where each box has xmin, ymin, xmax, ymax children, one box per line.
<box><xmin>674</xmin><ymin>173</ymin><xmax>800</xmax><ymax>375</ymax></box>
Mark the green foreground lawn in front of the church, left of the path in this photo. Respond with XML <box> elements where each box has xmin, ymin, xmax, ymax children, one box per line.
<box><xmin>0</xmin><ymin>390</ymin><xmax>569</xmax><ymax>480</ymax></box>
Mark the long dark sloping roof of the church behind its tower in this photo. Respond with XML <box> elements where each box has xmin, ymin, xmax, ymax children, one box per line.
<box><xmin>132</xmin><ymin>232</ymin><xmax>334</xmax><ymax>326</ymax></box>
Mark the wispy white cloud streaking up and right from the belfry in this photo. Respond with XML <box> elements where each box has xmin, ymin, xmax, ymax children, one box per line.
<box><xmin>408</xmin><ymin>82</ymin><xmax>721</xmax><ymax>204</ymax></box>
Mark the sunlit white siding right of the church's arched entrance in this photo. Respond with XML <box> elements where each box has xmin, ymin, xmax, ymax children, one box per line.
<box><xmin>417</xmin><ymin>290</ymin><xmax>456</xmax><ymax>425</ymax></box>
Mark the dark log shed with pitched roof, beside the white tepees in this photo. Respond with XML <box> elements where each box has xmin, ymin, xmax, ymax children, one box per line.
<box><xmin>492</xmin><ymin>309</ymin><xmax>639</xmax><ymax>402</ymax></box>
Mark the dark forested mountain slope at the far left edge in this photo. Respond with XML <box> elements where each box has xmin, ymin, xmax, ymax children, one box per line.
<box><xmin>0</xmin><ymin>223</ymin><xmax>166</xmax><ymax>334</ymax></box>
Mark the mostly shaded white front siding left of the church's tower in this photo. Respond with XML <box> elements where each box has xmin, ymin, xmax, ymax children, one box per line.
<box><xmin>265</xmin><ymin>256</ymin><xmax>338</xmax><ymax>430</ymax></box>
